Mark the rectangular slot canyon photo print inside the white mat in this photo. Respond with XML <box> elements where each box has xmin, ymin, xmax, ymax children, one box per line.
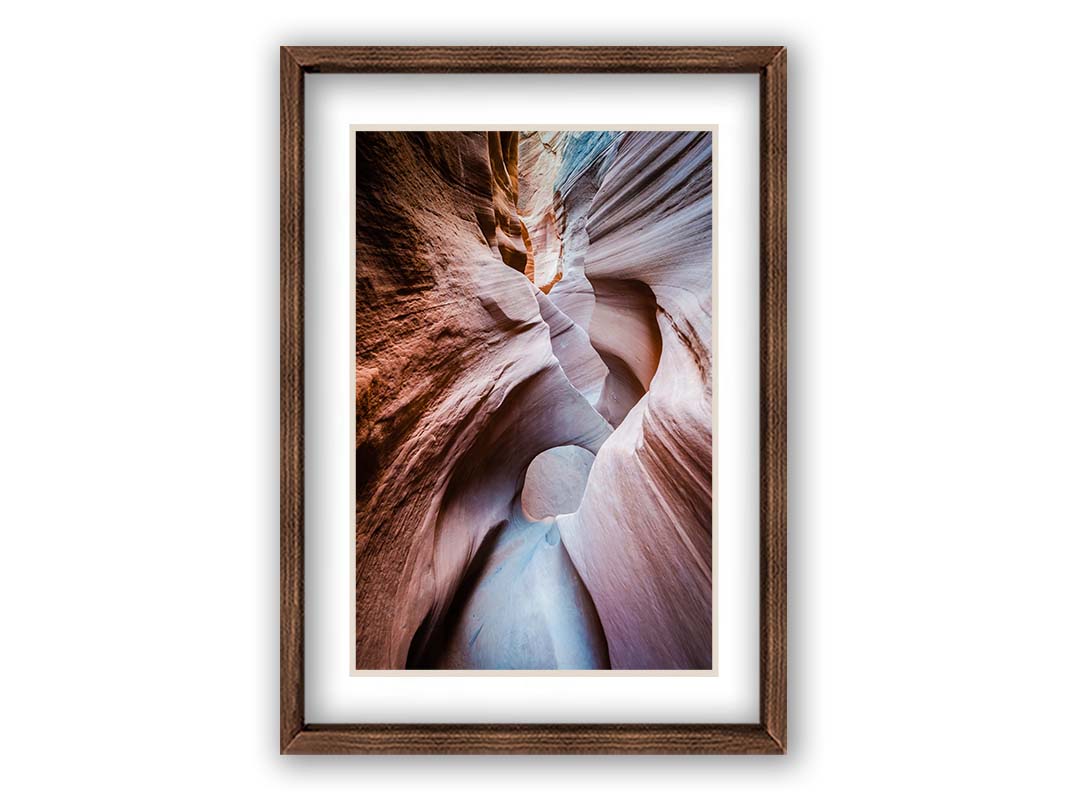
<box><xmin>355</xmin><ymin>131</ymin><xmax>712</xmax><ymax>669</ymax></box>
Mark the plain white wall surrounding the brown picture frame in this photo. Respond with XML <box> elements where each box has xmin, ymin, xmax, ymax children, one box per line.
<box><xmin>0</xmin><ymin>0</ymin><xmax>1067</xmax><ymax>798</ymax></box>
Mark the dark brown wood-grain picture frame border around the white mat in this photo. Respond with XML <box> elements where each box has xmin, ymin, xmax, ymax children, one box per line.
<box><xmin>281</xmin><ymin>47</ymin><xmax>786</xmax><ymax>753</ymax></box>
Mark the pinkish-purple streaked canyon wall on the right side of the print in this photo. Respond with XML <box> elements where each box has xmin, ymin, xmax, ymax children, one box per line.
<box><xmin>559</xmin><ymin>131</ymin><xmax>712</xmax><ymax>669</ymax></box>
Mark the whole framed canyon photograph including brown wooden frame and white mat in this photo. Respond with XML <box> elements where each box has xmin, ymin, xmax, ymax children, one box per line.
<box><xmin>281</xmin><ymin>47</ymin><xmax>786</xmax><ymax>754</ymax></box>
